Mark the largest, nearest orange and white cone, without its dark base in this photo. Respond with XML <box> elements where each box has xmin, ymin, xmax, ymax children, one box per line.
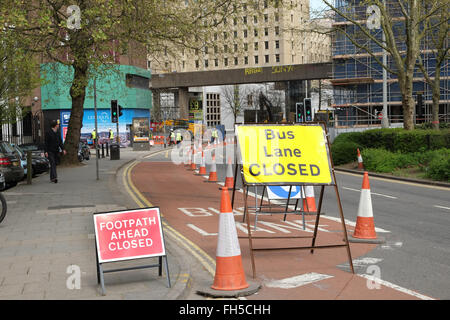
<box><xmin>211</xmin><ymin>188</ymin><xmax>249</xmax><ymax>291</ymax></box>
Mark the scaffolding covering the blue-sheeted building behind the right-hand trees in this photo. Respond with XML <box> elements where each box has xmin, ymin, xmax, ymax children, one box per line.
<box><xmin>331</xmin><ymin>0</ymin><xmax>450</xmax><ymax>126</ymax></box>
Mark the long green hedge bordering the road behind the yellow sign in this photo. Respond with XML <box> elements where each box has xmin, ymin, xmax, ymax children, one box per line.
<box><xmin>331</xmin><ymin>129</ymin><xmax>450</xmax><ymax>181</ymax></box>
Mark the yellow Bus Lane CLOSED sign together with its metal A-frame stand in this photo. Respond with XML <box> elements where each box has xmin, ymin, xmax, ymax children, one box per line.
<box><xmin>232</xmin><ymin>122</ymin><xmax>354</xmax><ymax>278</ymax></box>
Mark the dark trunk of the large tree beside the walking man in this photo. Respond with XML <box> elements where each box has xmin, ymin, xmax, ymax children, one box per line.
<box><xmin>63</xmin><ymin>59</ymin><xmax>89</xmax><ymax>164</ymax></box>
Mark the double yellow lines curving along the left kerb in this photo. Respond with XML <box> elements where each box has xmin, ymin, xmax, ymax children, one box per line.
<box><xmin>122</xmin><ymin>152</ymin><xmax>216</xmax><ymax>275</ymax></box>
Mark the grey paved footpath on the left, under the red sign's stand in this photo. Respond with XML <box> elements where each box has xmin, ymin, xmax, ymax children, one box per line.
<box><xmin>0</xmin><ymin>146</ymin><xmax>189</xmax><ymax>300</ymax></box>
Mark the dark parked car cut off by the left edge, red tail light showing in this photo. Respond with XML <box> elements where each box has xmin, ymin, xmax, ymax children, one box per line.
<box><xmin>0</xmin><ymin>141</ymin><xmax>24</xmax><ymax>186</ymax></box>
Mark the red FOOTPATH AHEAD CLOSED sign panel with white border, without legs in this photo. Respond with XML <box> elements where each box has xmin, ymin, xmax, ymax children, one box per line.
<box><xmin>94</xmin><ymin>207</ymin><xmax>166</xmax><ymax>263</ymax></box>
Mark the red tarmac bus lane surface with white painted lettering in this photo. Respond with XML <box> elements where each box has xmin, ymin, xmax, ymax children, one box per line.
<box><xmin>131</xmin><ymin>162</ymin><xmax>417</xmax><ymax>300</ymax></box>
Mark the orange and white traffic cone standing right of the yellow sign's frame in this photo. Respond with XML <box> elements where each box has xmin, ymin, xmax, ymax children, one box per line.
<box><xmin>349</xmin><ymin>171</ymin><xmax>384</xmax><ymax>243</ymax></box>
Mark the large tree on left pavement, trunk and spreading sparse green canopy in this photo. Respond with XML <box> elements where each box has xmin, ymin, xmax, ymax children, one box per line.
<box><xmin>0</xmin><ymin>0</ymin><xmax>270</xmax><ymax>164</ymax></box>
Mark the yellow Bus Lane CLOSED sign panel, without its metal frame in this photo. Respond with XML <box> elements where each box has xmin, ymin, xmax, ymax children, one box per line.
<box><xmin>236</xmin><ymin>125</ymin><xmax>333</xmax><ymax>185</ymax></box>
